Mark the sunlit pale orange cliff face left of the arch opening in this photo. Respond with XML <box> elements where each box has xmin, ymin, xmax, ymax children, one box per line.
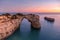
<box><xmin>0</xmin><ymin>14</ymin><xmax>23</xmax><ymax>39</ymax></box>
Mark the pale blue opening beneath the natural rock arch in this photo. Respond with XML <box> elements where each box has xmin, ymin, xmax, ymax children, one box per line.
<box><xmin>20</xmin><ymin>18</ymin><xmax>31</xmax><ymax>32</ymax></box>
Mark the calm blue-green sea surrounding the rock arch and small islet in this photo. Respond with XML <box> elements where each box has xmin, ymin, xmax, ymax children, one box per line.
<box><xmin>7</xmin><ymin>14</ymin><xmax>60</xmax><ymax>40</ymax></box>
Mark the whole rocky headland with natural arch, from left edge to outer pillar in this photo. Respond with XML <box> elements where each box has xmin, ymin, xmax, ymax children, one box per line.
<box><xmin>0</xmin><ymin>13</ymin><xmax>40</xmax><ymax>40</ymax></box>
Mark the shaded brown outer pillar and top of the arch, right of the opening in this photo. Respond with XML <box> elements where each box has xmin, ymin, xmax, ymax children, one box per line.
<box><xmin>25</xmin><ymin>14</ymin><xmax>40</xmax><ymax>29</ymax></box>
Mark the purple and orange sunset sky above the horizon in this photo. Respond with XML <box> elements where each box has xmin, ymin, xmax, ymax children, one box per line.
<box><xmin>0</xmin><ymin>0</ymin><xmax>60</xmax><ymax>12</ymax></box>
